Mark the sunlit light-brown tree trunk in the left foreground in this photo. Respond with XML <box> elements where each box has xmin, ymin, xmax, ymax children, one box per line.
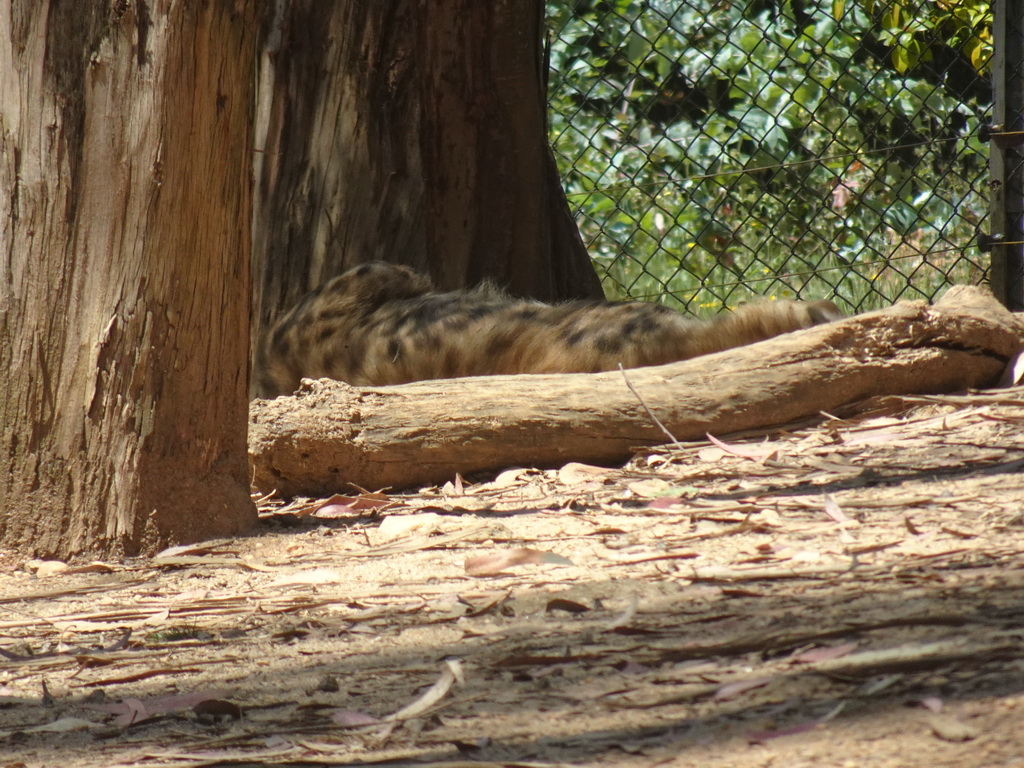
<box><xmin>0</xmin><ymin>0</ymin><xmax>256</xmax><ymax>555</ymax></box>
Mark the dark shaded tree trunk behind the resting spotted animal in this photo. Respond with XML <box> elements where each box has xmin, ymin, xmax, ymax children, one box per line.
<box><xmin>254</xmin><ymin>0</ymin><xmax>601</xmax><ymax>348</ymax></box>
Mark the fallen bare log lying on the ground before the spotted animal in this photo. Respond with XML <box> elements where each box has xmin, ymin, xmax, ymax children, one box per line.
<box><xmin>249</xmin><ymin>287</ymin><xmax>1024</xmax><ymax>498</ymax></box>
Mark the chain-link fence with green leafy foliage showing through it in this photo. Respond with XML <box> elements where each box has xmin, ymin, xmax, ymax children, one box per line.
<box><xmin>548</xmin><ymin>0</ymin><xmax>991</xmax><ymax>311</ymax></box>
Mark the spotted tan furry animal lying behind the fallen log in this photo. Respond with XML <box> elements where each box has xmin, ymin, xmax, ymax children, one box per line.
<box><xmin>256</xmin><ymin>262</ymin><xmax>842</xmax><ymax>397</ymax></box>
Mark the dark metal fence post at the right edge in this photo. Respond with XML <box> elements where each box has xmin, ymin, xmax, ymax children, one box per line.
<box><xmin>982</xmin><ymin>0</ymin><xmax>1024</xmax><ymax>311</ymax></box>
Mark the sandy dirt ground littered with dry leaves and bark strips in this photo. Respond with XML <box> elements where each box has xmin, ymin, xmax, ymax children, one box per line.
<box><xmin>0</xmin><ymin>388</ymin><xmax>1024</xmax><ymax>768</ymax></box>
